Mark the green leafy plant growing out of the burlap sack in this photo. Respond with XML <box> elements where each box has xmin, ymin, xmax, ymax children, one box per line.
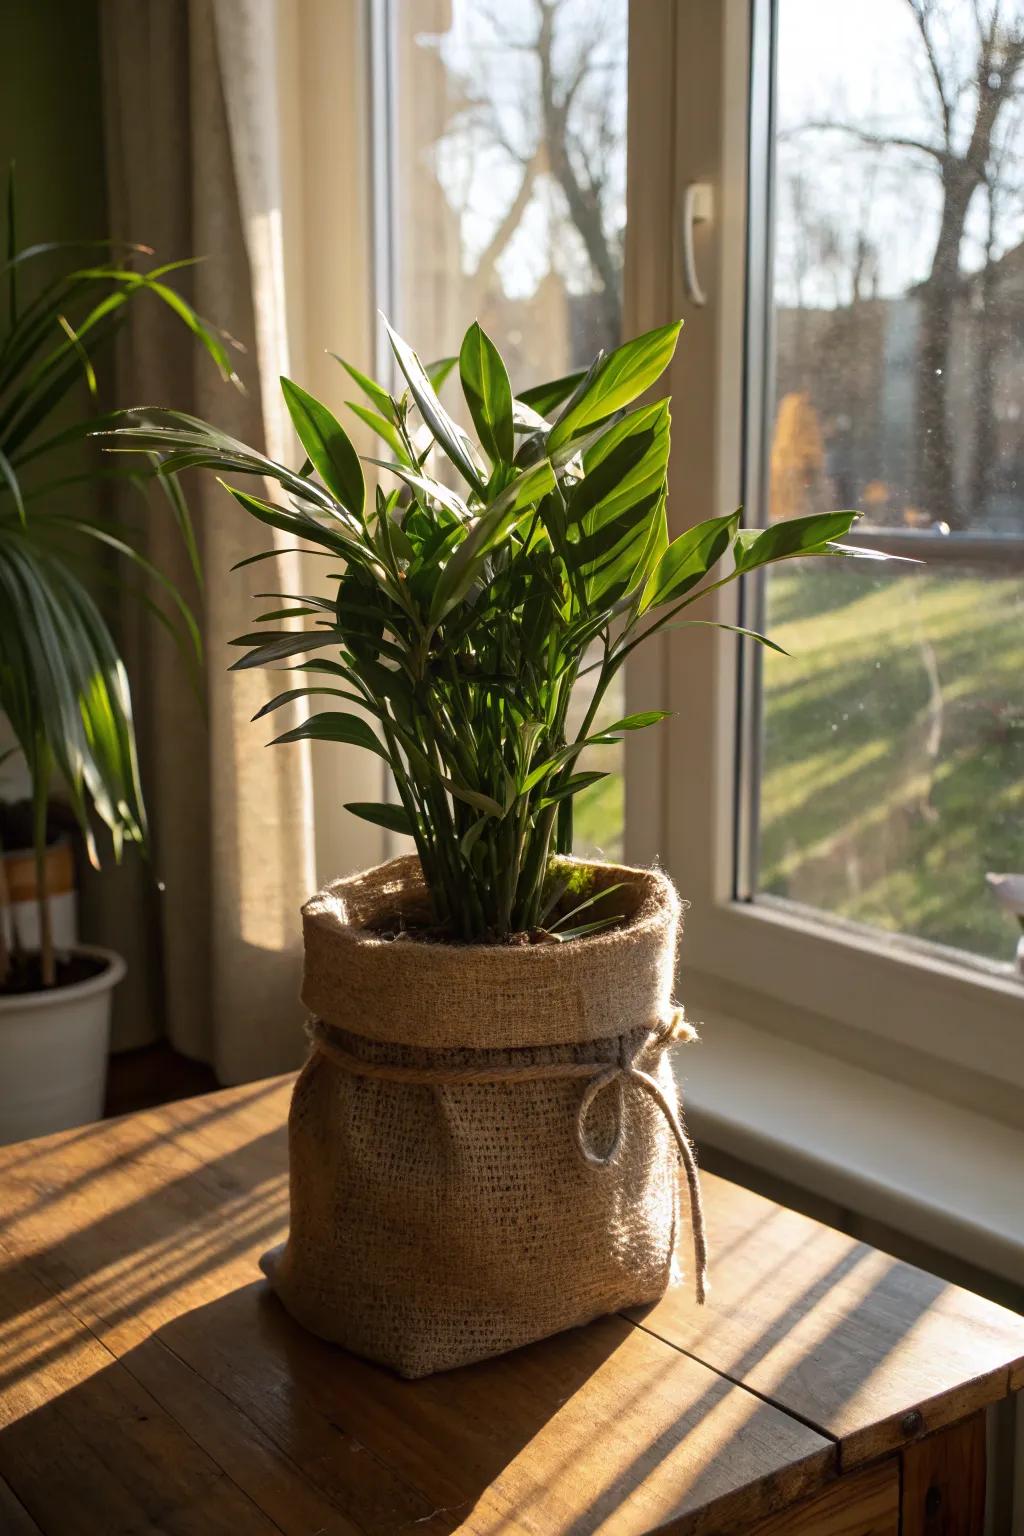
<box><xmin>99</xmin><ymin>324</ymin><xmax>890</xmax><ymax>942</ymax></box>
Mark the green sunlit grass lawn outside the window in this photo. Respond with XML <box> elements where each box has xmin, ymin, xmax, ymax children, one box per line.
<box><xmin>576</xmin><ymin>561</ymin><xmax>1024</xmax><ymax>960</ymax></box>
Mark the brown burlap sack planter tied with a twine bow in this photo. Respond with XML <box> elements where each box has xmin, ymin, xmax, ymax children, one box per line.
<box><xmin>263</xmin><ymin>859</ymin><xmax>703</xmax><ymax>1376</ymax></box>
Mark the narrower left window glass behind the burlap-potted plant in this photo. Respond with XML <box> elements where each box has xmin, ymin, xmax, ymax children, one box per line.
<box><xmin>395</xmin><ymin>0</ymin><xmax>628</xmax><ymax>857</ymax></box>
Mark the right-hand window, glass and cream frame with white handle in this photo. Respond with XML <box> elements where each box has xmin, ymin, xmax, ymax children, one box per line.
<box><xmin>641</xmin><ymin>0</ymin><xmax>1024</xmax><ymax>1111</ymax></box>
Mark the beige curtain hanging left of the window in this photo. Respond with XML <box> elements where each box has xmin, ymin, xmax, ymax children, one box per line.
<box><xmin>94</xmin><ymin>0</ymin><xmax>313</xmax><ymax>1083</ymax></box>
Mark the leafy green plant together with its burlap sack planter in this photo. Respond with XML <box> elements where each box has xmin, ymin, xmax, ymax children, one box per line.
<box><xmin>105</xmin><ymin>324</ymin><xmax>896</xmax><ymax>1376</ymax></box>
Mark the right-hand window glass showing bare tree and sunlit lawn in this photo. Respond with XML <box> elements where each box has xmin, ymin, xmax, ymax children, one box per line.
<box><xmin>758</xmin><ymin>0</ymin><xmax>1024</xmax><ymax>960</ymax></box>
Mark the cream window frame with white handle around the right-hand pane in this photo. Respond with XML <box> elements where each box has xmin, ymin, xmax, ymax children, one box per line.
<box><xmin>626</xmin><ymin>0</ymin><xmax>1024</xmax><ymax>1109</ymax></box>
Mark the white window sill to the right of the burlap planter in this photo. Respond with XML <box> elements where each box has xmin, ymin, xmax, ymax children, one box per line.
<box><xmin>677</xmin><ymin>1014</ymin><xmax>1024</xmax><ymax>1284</ymax></box>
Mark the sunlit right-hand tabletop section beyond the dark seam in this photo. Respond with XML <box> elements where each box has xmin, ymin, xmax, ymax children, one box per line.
<box><xmin>631</xmin><ymin>1177</ymin><xmax>1024</xmax><ymax>1468</ymax></box>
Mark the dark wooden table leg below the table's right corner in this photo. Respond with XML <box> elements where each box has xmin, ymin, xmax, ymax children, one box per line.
<box><xmin>900</xmin><ymin>1410</ymin><xmax>986</xmax><ymax>1536</ymax></box>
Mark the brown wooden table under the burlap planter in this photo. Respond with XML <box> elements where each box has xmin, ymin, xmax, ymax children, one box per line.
<box><xmin>0</xmin><ymin>1080</ymin><xmax>1024</xmax><ymax>1536</ymax></box>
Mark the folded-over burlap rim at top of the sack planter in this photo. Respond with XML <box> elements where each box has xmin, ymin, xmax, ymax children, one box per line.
<box><xmin>302</xmin><ymin>856</ymin><xmax>682</xmax><ymax>1049</ymax></box>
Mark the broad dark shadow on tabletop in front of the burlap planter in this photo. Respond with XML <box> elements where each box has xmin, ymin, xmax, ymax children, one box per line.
<box><xmin>0</xmin><ymin>1281</ymin><xmax>629</xmax><ymax>1536</ymax></box>
